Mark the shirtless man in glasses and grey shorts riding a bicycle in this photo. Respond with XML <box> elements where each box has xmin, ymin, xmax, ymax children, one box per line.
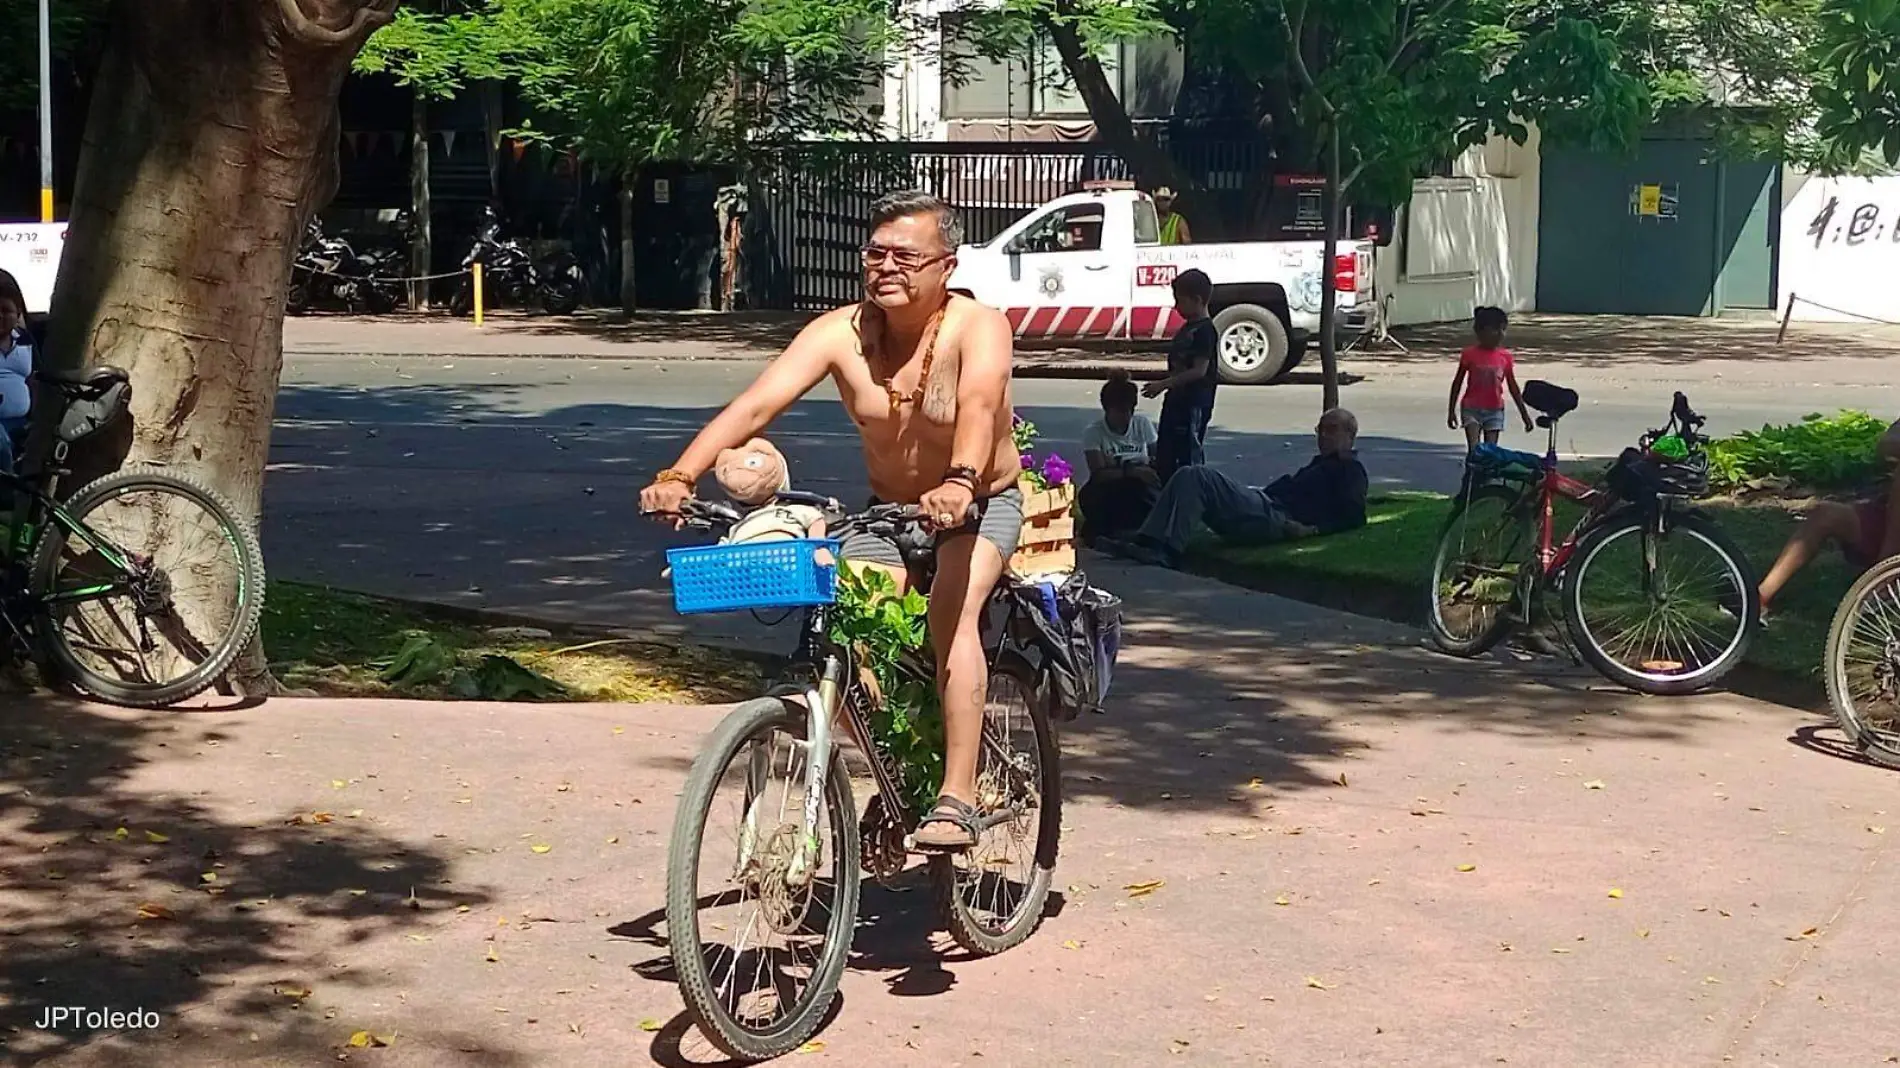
<box><xmin>640</xmin><ymin>192</ymin><xmax>1022</xmax><ymax>851</ymax></box>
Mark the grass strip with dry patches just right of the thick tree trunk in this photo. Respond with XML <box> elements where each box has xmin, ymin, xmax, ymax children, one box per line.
<box><xmin>264</xmin><ymin>582</ymin><xmax>762</xmax><ymax>703</ymax></box>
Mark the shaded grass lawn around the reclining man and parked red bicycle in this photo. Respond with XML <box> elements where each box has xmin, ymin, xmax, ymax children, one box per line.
<box><xmin>1189</xmin><ymin>494</ymin><xmax>1853</xmax><ymax>682</ymax></box>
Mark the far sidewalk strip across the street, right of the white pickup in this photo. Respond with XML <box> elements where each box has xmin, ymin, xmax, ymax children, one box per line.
<box><xmin>1364</xmin><ymin>315</ymin><xmax>1900</xmax><ymax>369</ymax></box>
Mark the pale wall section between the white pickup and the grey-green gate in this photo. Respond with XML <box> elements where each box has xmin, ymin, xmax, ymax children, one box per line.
<box><xmin>1378</xmin><ymin>129</ymin><xmax>1541</xmax><ymax>325</ymax></box>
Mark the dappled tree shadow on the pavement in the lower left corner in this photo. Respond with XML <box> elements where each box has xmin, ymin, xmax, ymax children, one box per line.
<box><xmin>0</xmin><ymin>697</ymin><xmax>523</xmax><ymax>1066</ymax></box>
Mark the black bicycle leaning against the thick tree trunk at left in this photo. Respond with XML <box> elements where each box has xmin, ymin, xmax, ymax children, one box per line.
<box><xmin>0</xmin><ymin>367</ymin><xmax>264</xmax><ymax>709</ymax></box>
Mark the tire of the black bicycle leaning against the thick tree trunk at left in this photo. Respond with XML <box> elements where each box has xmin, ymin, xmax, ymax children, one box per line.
<box><xmin>29</xmin><ymin>466</ymin><xmax>266</xmax><ymax>709</ymax></box>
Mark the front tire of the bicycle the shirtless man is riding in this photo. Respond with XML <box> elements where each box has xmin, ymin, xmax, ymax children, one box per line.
<box><xmin>667</xmin><ymin>697</ymin><xmax>863</xmax><ymax>1060</ymax></box>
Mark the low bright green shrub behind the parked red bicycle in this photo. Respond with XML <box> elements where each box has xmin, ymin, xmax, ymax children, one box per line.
<box><xmin>1708</xmin><ymin>410</ymin><xmax>1887</xmax><ymax>490</ymax></box>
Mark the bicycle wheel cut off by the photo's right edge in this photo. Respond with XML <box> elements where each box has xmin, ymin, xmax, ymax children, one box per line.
<box><xmin>1826</xmin><ymin>557</ymin><xmax>1900</xmax><ymax>768</ymax></box>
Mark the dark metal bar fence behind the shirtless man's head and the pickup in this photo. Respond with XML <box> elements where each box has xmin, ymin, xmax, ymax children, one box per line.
<box><xmin>749</xmin><ymin>141</ymin><xmax>1264</xmax><ymax>310</ymax></box>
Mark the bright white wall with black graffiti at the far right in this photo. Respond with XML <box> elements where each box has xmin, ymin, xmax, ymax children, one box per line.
<box><xmin>1778</xmin><ymin>171</ymin><xmax>1900</xmax><ymax>323</ymax></box>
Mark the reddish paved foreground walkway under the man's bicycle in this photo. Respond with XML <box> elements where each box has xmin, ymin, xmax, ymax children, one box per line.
<box><xmin>0</xmin><ymin>564</ymin><xmax>1900</xmax><ymax>1068</ymax></box>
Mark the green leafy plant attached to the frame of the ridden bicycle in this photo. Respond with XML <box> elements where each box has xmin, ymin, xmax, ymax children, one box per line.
<box><xmin>827</xmin><ymin>566</ymin><xmax>944</xmax><ymax>811</ymax></box>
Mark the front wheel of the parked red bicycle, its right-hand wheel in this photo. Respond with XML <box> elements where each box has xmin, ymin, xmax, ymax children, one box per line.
<box><xmin>1564</xmin><ymin>511</ymin><xmax>1761</xmax><ymax>696</ymax></box>
